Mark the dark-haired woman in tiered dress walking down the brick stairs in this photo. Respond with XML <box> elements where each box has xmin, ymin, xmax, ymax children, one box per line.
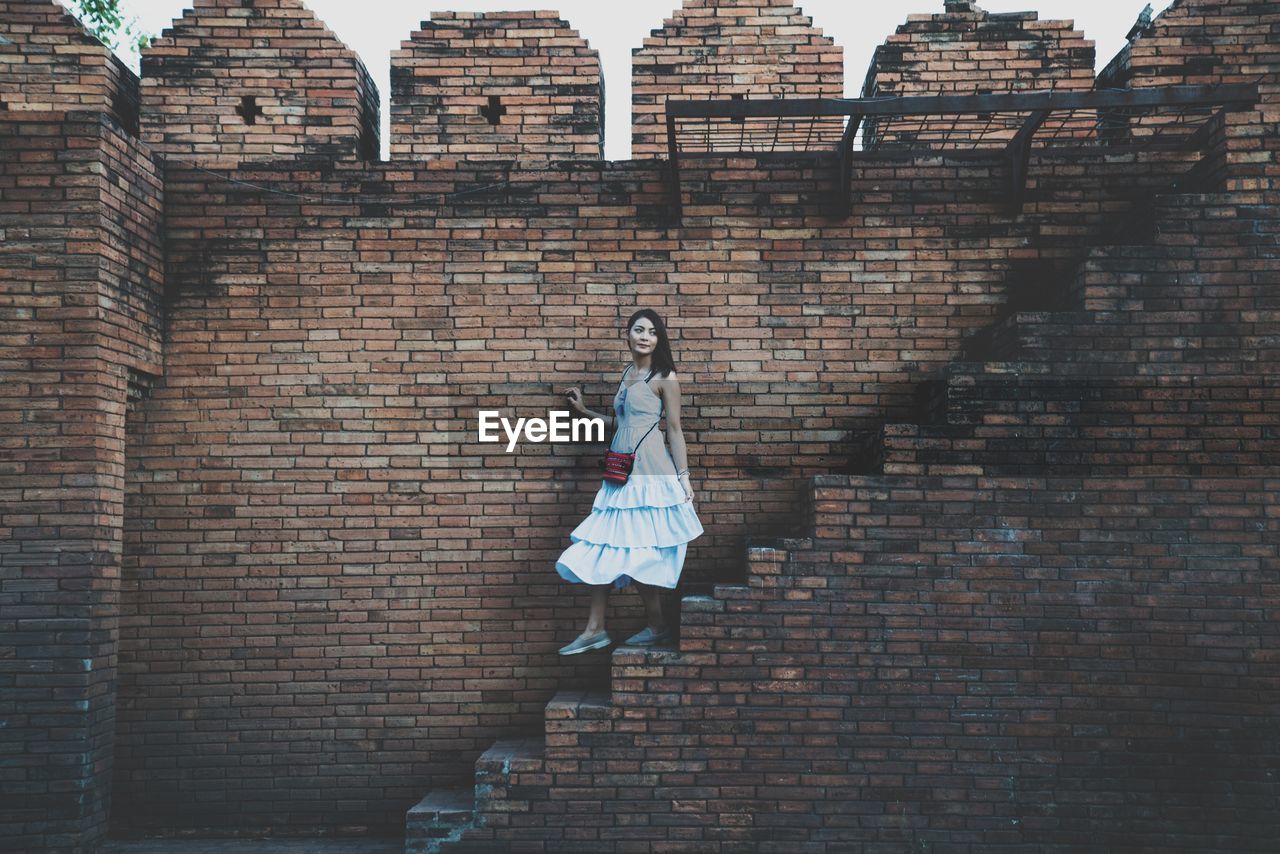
<box><xmin>556</xmin><ymin>309</ymin><xmax>703</xmax><ymax>656</ymax></box>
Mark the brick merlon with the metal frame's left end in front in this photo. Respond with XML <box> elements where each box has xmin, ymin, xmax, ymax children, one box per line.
<box><xmin>631</xmin><ymin>0</ymin><xmax>845</xmax><ymax>157</ymax></box>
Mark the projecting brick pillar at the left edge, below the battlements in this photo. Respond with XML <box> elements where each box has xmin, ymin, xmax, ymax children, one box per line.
<box><xmin>0</xmin><ymin>111</ymin><xmax>161</xmax><ymax>850</ymax></box>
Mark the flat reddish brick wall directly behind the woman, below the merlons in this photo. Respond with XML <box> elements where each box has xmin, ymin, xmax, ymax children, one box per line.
<box><xmin>107</xmin><ymin>142</ymin><xmax>1208</xmax><ymax>827</ymax></box>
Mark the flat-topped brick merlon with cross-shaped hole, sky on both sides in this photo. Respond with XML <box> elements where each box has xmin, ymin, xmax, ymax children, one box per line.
<box><xmin>392</xmin><ymin>12</ymin><xmax>604</xmax><ymax>160</ymax></box>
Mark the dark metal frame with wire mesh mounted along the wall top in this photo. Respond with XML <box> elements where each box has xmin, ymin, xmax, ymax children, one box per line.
<box><xmin>666</xmin><ymin>83</ymin><xmax>1258</xmax><ymax>220</ymax></box>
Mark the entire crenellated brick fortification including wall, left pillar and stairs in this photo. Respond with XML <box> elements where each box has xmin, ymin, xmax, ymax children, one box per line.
<box><xmin>0</xmin><ymin>0</ymin><xmax>1280</xmax><ymax>854</ymax></box>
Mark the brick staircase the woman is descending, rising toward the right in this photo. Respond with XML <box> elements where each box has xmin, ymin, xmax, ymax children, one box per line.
<box><xmin>406</xmin><ymin>188</ymin><xmax>1280</xmax><ymax>853</ymax></box>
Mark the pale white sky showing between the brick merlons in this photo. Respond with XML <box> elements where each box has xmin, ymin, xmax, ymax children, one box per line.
<box><xmin>110</xmin><ymin>0</ymin><xmax>1169</xmax><ymax>160</ymax></box>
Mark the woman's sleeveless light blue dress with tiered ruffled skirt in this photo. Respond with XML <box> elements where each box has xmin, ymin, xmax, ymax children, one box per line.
<box><xmin>556</xmin><ymin>367</ymin><xmax>703</xmax><ymax>589</ymax></box>
